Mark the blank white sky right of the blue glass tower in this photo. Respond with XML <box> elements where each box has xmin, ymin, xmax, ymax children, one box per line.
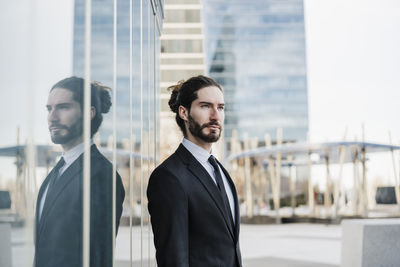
<box><xmin>305</xmin><ymin>0</ymin><xmax>400</xmax><ymax>143</ymax></box>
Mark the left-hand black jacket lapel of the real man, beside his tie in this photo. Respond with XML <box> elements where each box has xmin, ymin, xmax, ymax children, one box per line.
<box><xmin>177</xmin><ymin>144</ymin><xmax>236</xmax><ymax>240</ymax></box>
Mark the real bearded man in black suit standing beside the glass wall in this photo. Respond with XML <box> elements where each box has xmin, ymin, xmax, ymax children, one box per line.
<box><xmin>147</xmin><ymin>76</ymin><xmax>241</xmax><ymax>267</ymax></box>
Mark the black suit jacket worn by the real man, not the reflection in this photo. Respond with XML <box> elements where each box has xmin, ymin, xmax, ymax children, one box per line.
<box><xmin>147</xmin><ymin>144</ymin><xmax>241</xmax><ymax>267</ymax></box>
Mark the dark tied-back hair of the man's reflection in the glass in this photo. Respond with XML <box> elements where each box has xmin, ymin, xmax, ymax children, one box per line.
<box><xmin>50</xmin><ymin>76</ymin><xmax>111</xmax><ymax>137</ymax></box>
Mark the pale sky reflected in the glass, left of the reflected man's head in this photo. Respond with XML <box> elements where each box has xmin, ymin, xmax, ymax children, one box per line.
<box><xmin>0</xmin><ymin>0</ymin><xmax>73</xmax><ymax>147</ymax></box>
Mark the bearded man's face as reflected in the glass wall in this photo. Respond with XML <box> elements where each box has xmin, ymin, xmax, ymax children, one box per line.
<box><xmin>46</xmin><ymin>88</ymin><xmax>82</xmax><ymax>145</ymax></box>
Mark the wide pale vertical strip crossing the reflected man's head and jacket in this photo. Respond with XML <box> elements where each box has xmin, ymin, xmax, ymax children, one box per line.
<box><xmin>83</xmin><ymin>0</ymin><xmax>92</xmax><ymax>267</ymax></box>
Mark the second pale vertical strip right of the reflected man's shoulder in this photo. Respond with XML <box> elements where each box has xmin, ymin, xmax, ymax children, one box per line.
<box><xmin>139</xmin><ymin>0</ymin><xmax>144</xmax><ymax>267</ymax></box>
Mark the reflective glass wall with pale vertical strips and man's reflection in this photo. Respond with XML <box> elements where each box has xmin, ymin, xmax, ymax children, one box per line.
<box><xmin>0</xmin><ymin>0</ymin><xmax>163</xmax><ymax>267</ymax></box>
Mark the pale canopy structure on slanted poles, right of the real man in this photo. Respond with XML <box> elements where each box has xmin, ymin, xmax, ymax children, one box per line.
<box><xmin>228</xmin><ymin>140</ymin><xmax>400</xmax><ymax>221</ymax></box>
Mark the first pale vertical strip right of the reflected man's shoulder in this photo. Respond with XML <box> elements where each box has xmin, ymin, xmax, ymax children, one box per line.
<box><xmin>129</xmin><ymin>0</ymin><xmax>134</xmax><ymax>267</ymax></box>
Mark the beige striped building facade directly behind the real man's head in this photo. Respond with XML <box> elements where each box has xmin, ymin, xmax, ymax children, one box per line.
<box><xmin>160</xmin><ymin>0</ymin><xmax>205</xmax><ymax>159</ymax></box>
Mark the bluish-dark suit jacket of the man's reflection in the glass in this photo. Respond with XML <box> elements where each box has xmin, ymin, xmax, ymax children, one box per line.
<box><xmin>35</xmin><ymin>145</ymin><xmax>125</xmax><ymax>267</ymax></box>
